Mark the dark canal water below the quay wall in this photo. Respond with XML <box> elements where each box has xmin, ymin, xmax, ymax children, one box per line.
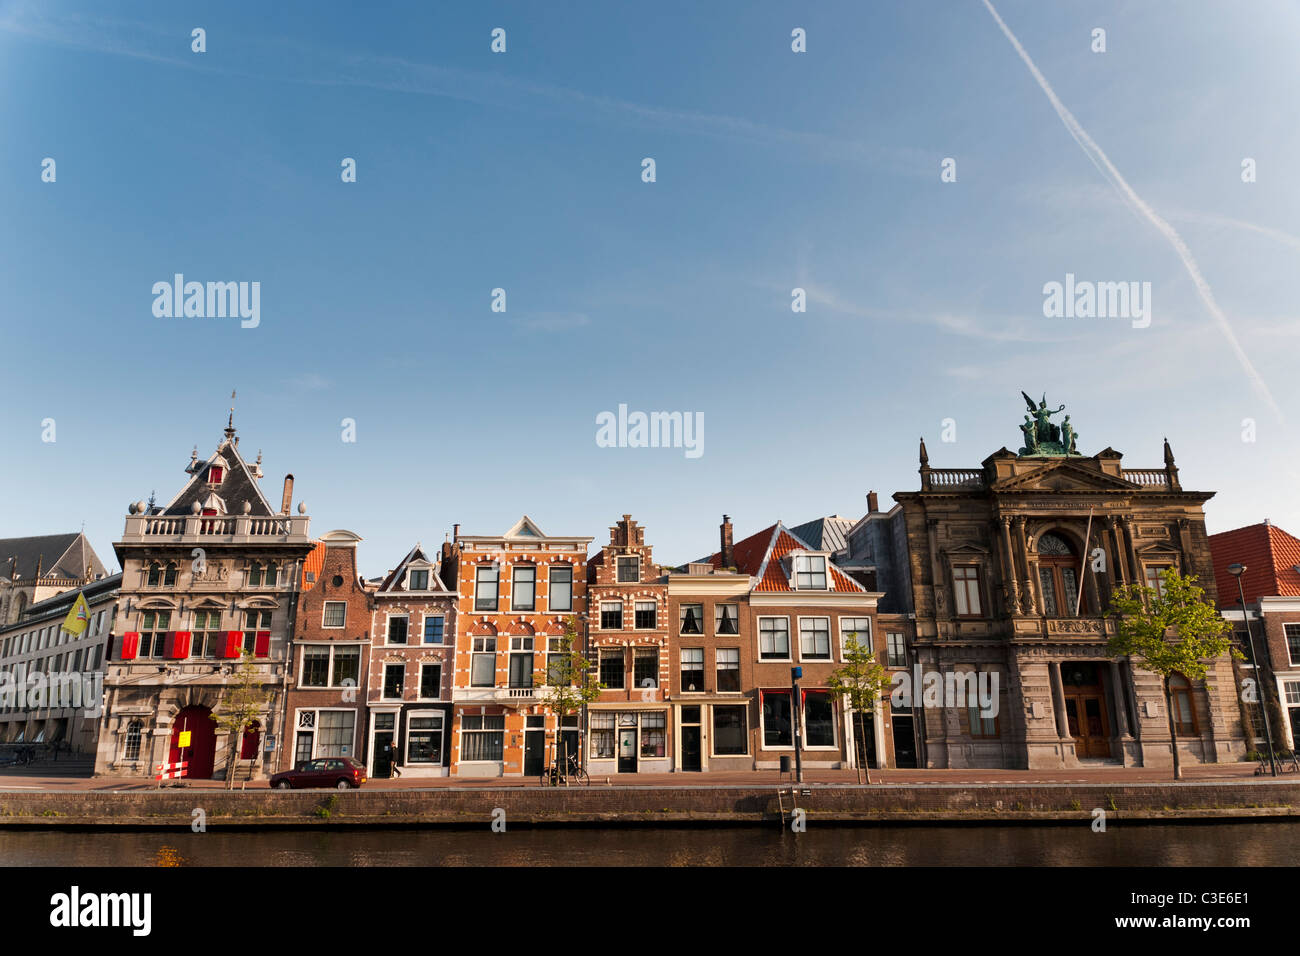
<box><xmin>0</xmin><ymin>821</ymin><xmax>1300</xmax><ymax>866</ymax></box>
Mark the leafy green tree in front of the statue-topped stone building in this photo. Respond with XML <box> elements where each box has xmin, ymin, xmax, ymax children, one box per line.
<box><xmin>1106</xmin><ymin>567</ymin><xmax>1242</xmax><ymax>780</ymax></box>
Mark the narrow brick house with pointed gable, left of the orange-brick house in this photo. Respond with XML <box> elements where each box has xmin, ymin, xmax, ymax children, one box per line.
<box><xmin>365</xmin><ymin>544</ymin><xmax>456</xmax><ymax>779</ymax></box>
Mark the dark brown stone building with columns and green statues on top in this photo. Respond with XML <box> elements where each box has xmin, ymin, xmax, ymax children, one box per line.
<box><xmin>894</xmin><ymin>403</ymin><xmax>1245</xmax><ymax>769</ymax></box>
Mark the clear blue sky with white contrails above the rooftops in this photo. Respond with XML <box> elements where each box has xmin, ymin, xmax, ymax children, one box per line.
<box><xmin>0</xmin><ymin>0</ymin><xmax>1300</xmax><ymax>574</ymax></box>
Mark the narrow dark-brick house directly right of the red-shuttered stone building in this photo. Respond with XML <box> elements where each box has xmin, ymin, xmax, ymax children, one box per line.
<box><xmin>278</xmin><ymin>531</ymin><xmax>373</xmax><ymax>770</ymax></box>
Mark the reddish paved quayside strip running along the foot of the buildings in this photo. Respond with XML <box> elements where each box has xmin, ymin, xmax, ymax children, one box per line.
<box><xmin>0</xmin><ymin>761</ymin><xmax>1268</xmax><ymax>792</ymax></box>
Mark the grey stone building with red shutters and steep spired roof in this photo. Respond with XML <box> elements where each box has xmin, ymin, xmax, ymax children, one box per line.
<box><xmin>95</xmin><ymin>421</ymin><xmax>312</xmax><ymax>779</ymax></box>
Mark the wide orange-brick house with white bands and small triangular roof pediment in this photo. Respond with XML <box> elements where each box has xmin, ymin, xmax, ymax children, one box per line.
<box><xmin>441</xmin><ymin>515</ymin><xmax>592</xmax><ymax>777</ymax></box>
